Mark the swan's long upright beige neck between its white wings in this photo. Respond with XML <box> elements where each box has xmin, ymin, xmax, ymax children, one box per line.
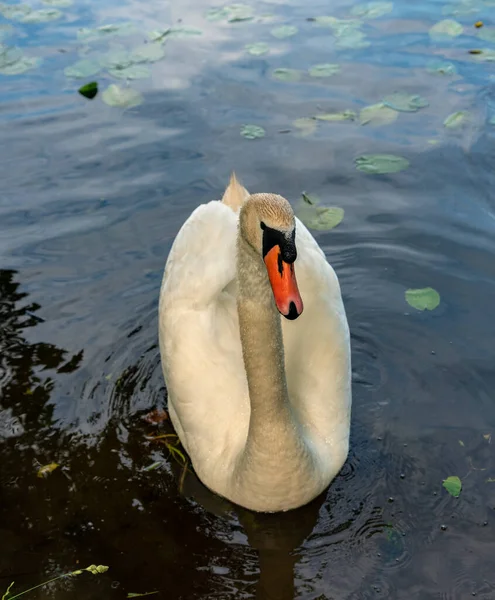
<box><xmin>237</xmin><ymin>235</ymin><xmax>291</xmax><ymax>432</ymax></box>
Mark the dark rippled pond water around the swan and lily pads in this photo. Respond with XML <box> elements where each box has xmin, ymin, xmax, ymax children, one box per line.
<box><xmin>0</xmin><ymin>0</ymin><xmax>495</xmax><ymax>600</ymax></box>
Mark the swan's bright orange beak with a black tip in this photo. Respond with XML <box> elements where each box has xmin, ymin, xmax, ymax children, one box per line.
<box><xmin>264</xmin><ymin>245</ymin><xmax>303</xmax><ymax>320</ymax></box>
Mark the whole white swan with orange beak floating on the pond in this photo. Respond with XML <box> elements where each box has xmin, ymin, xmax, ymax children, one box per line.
<box><xmin>158</xmin><ymin>174</ymin><xmax>352</xmax><ymax>512</ymax></box>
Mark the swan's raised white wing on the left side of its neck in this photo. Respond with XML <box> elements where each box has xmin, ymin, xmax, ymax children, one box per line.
<box><xmin>159</xmin><ymin>201</ymin><xmax>249</xmax><ymax>487</ymax></box>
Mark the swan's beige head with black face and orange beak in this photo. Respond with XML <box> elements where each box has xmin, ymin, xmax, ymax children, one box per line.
<box><xmin>240</xmin><ymin>194</ymin><xmax>303</xmax><ymax>320</ymax></box>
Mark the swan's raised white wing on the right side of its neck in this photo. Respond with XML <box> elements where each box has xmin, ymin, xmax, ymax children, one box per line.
<box><xmin>282</xmin><ymin>220</ymin><xmax>351</xmax><ymax>474</ymax></box>
